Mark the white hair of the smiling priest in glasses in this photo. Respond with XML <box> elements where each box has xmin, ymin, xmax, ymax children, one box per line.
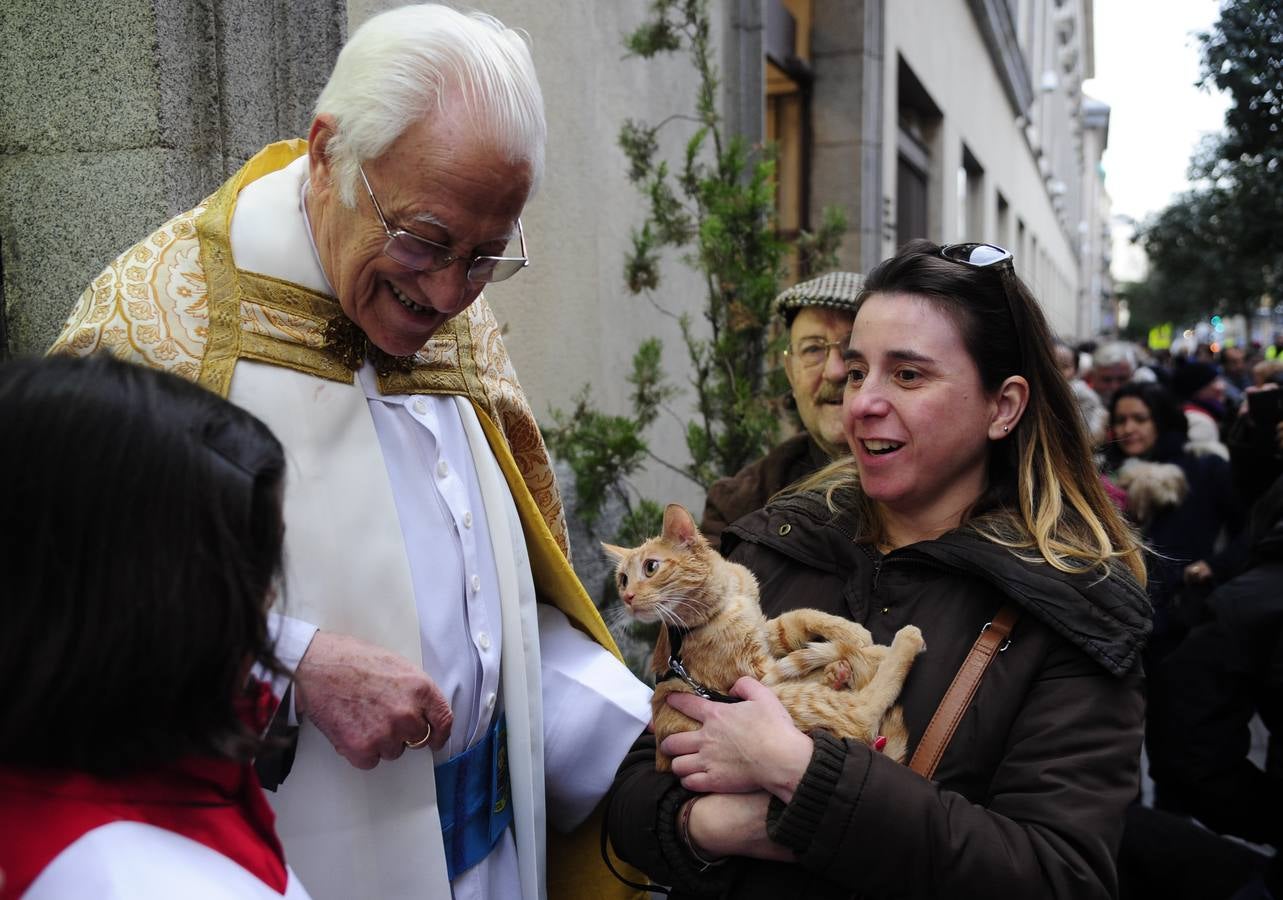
<box><xmin>316</xmin><ymin>4</ymin><xmax>548</xmax><ymax>207</ymax></box>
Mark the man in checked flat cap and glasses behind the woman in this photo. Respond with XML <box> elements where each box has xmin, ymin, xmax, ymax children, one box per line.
<box><xmin>699</xmin><ymin>272</ymin><xmax>863</xmax><ymax>547</ymax></box>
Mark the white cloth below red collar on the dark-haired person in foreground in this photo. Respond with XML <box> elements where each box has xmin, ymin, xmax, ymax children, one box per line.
<box><xmin>22</xmin><ymin>822</ymin><xmax>310</xmax><ymax>900</ymax></box>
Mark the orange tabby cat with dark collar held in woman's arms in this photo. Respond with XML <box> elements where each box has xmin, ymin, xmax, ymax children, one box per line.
<box><xmin>602</xmin><ymin>503</ymin><xmax>926</xmax><ymax>772</ymax></box>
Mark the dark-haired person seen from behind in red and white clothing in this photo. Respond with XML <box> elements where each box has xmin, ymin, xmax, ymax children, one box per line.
<box><xmin>0</xmin><ymin>356</ymin><xmax>308</xmax><ymax>900</ymax></box>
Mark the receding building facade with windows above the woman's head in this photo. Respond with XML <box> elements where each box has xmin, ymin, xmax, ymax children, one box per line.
<box><xmin>766</xmin><ymin>0</ymin><xmax>1111</xmax><ymax>339</ymax></box>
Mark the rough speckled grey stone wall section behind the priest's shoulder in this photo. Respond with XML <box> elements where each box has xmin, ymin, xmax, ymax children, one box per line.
<box><xmin>0</xmin><ymin>0</ymin><xmax>346</xmax><ymax>353</ymax></box>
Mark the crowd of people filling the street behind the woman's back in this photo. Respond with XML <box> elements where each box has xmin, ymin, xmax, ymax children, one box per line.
<box><xmin>1062</xmin><ymin>335</ymin><xmax>1283</xmax><ymax>897</ymax></box>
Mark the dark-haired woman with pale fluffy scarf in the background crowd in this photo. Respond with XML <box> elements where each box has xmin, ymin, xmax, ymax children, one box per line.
<box><xmin>1106</xmin><ymin>380</ymin><xmax>1245</xmax><ymax>660</ymax></box>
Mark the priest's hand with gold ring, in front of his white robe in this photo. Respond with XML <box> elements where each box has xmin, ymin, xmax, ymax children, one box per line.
<box><xmin>294</xmin><ymin>632</ymin><xmax>454</xmax><ymax>769</ymax></box>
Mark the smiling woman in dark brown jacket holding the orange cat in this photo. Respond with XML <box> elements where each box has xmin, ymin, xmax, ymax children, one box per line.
<box><xmin>608</xmin><ymin>241</ymin><xmax>1148</xmax><ymax>897</ymax></box>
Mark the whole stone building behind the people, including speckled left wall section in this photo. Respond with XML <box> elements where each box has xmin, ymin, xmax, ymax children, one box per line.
<box><xmin>0</xmin><ymin>0</ymin><xmax>1111</xmax><ymax>508</ymax></box>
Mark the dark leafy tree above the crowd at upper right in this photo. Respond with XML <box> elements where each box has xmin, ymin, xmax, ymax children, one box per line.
<box><xmin>1124</xmin><ymin>0</ymin><xmax>1283</xmax><ymax>326</ymax></box>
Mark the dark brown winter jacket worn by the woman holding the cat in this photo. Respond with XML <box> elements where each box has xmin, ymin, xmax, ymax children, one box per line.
<box><xmin>608</xmin><ymin>497</ymin><xmax>1148</xmax><ymax>900</ymax></box>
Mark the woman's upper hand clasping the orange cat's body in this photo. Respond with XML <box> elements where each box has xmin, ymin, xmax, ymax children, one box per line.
<box><xmin>659</xmin><ymin>678</ymin><xmax>813</xmax><ymax>801</ymax></box>
